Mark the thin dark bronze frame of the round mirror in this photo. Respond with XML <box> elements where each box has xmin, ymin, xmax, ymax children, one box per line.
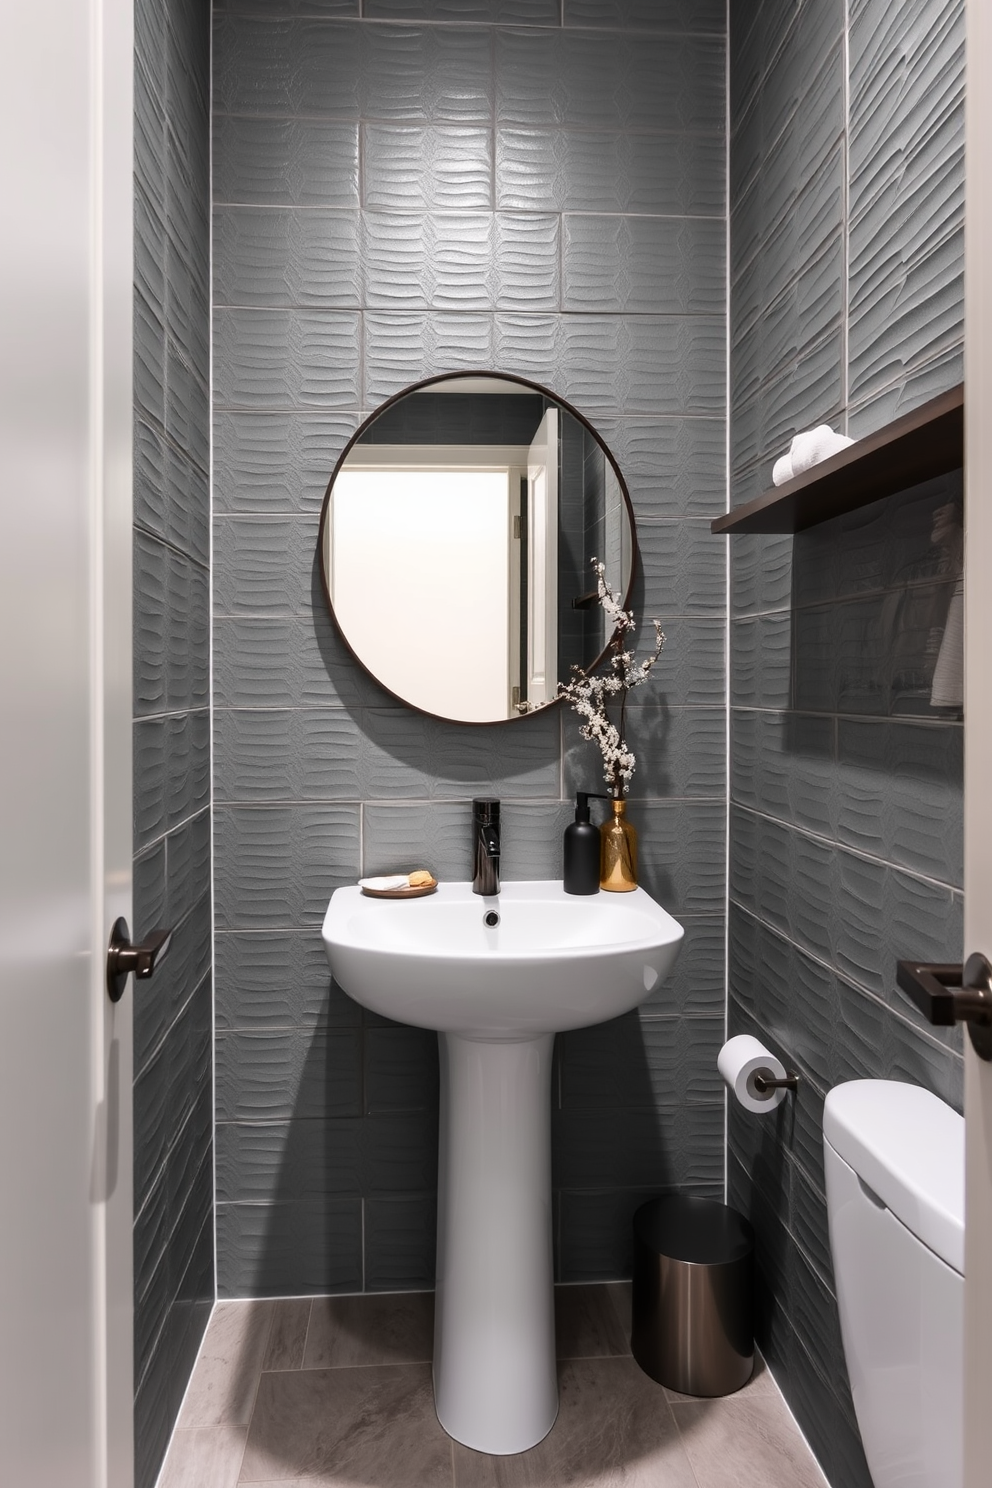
<box><xmin>317</xmin><ymin>368</ymin><xmax>641</xmax><ymax>729</ymax></box>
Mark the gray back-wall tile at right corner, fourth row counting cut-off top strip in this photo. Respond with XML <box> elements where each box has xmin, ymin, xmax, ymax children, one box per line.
<box><xmin>562</xmin><ymin>214</ymin><xmax>726</xmax><ymax>315</ymax></box>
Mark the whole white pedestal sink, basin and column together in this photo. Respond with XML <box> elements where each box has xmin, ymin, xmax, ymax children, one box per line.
<box><xmin>323</xmin><ymin>882</ymin><xmax>683</xmax><ymax>1455</ymax></box>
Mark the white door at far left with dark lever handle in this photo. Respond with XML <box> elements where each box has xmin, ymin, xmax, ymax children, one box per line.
<box><xmin>0</xmin><ymin>0</ymin><xmax>132</xmax><ymax>1488</ymax></box>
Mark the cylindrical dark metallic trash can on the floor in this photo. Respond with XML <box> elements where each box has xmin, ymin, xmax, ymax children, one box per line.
<box><xmin>631</xmin><ymin>1195</ymin><xmax>754</xmax><ymax>1396</ymax></box>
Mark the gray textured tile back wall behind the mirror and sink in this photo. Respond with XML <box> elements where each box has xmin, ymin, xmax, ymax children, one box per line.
<box><xmin>213</xmin><ymin>0</ymin><xmax>726</xmax><ymax>1296</ymax></box>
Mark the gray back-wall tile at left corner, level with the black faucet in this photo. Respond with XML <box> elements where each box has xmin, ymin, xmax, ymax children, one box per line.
<box><xmin>214</xmin><ymin>805</ymin><xmax>358</xmax><ymax>930</ymax></box>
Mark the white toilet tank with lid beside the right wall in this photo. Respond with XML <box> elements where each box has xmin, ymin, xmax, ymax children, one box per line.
<box><xmin>824</xmin><ymin>1080</ymin><xmax>964</xmax><ymax>1488</ymax></box>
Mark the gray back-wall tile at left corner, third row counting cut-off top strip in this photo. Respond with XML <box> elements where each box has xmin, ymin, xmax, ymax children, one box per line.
<box><xmin>214</xmin><ymin>115</ymin><xmax>358</xmax><ymax>207</ymax></box>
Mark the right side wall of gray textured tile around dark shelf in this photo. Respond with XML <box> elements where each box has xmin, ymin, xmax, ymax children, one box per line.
<box><xmin>729</xmin><ymin>0</ymin><xmax>964</xmax><ymax>1488</ymax></box>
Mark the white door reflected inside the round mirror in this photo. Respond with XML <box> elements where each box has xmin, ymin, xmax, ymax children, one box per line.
<box><xmin>526</xmin><ymin>408</ymin><xmax>558</xmax><ymax>707</ymax></box>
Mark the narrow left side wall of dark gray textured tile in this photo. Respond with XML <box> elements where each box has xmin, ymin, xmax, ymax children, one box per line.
<box><xmin>129</xmin><ymin>0</ymin><xmax>214</xmax><ymax>1488</ymax></box>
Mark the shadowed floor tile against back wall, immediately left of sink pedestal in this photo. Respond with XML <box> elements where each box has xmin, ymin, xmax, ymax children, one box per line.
<box><xmin>303</xmin><ymin>1292</ymin><xmax>434</xmax><ymax>1369</ymax></box>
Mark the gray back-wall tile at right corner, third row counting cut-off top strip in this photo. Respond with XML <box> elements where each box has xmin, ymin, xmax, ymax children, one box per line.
<box><xmin>495</xmin><ymin>126</ymin><xmax>726</xmax><ymax>217</ymax></box>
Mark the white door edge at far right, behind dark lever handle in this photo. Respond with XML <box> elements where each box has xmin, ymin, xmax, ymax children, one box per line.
<box><xmin>965</xmin><ymin>0</ymin><xmax>992</xmax><ymax>1488</ymax></box>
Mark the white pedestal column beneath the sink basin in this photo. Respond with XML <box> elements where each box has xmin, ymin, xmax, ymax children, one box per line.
<box><xmin>434</xmin><ymin>1033</ymin><xmax>558</xmax><ymax>1455</ymax></box>
